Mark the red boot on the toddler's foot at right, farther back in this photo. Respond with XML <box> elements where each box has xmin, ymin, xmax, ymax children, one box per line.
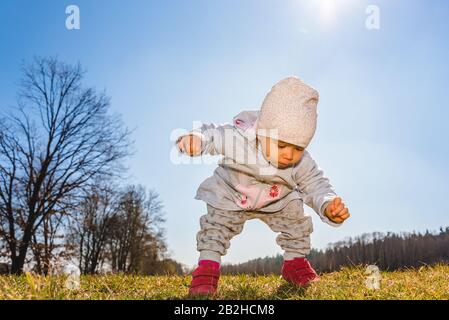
<box><xmin>282</xmin><ymin>258</ymin><xmax>320</xmax><ymax>287</ymax></box>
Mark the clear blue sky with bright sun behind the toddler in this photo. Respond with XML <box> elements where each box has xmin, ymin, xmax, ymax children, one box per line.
<box><xmin>0</xmin><ymin>0</ymin><xmax>449</xmax><ymax>265</ymax></box>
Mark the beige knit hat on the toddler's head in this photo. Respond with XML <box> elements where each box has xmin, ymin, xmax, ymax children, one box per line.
<box><xmin>257</xmin><ymin>76</ymin><xmax>319</xmax><ymax>148</ymax></box>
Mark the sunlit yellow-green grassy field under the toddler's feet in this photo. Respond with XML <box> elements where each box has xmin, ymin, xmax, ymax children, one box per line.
<box><xmin>0</xmin><ymin>265</ymin><xmax>449</xmax><ymax>300</ymax></box>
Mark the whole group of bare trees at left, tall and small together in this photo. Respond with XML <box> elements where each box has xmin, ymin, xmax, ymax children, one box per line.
<box><xmin>0</xmin><ymin>58</ymin><xmax>181</xmax><ymax>274</ymax></box>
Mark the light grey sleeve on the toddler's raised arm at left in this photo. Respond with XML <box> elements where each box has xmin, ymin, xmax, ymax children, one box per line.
<box><xmin>176</xmin><ymin>123</ymin><xmax>233</xmax><ymax>155</ymax></box>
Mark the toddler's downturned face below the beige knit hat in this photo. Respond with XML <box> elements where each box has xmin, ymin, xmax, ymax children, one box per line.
<box><xmin>258</xmin><ymin>136</ymin><xmax>304</xmax><ymax>169</ymax></box>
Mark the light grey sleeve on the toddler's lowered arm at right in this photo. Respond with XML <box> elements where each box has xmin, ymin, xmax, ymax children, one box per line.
<box><xmin>295</xmin><ymin>151</ymin><xmax>342</xmax><ymax>227</ymax></box>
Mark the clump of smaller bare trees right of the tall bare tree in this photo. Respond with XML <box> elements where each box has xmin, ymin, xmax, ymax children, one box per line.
<box><xmin>68</xmin><ymin>182</ymin><xmax>168</xmax><ymax>274</ymax></box>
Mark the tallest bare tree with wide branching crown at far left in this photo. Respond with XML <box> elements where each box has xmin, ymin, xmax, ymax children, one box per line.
<box><xmin>0</xmin><ymin>58</ymin><xmax>129</xmax><ymax>273</ymax></box>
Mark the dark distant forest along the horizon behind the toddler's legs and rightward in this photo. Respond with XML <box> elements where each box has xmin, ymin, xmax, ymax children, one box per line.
<box><xmin>222</xmin><ymin>227</ymin><xmax>449</xmax><ymax>274</ymax></box>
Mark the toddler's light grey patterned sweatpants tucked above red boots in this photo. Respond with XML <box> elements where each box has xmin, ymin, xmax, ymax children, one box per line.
<box><xmin>196</xmin><ymin>200</ymin><xmax>313</xmax><ymax>262</ymax></box>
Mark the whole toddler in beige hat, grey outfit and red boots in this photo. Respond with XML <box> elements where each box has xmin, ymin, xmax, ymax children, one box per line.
<box><xmin>176</xmin><ymin>77</ymin><xmax>349</xmax><ymax>296</ymax></box>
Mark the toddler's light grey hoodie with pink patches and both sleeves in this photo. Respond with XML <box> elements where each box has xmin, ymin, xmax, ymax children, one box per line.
<box><xmin>178</xmin><ymin>111</ymin><xmax>341</xmax><ymax>226</ymax></box>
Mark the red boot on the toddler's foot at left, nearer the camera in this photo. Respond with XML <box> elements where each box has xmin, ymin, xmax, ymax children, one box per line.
<box><xmin>189</xmin><ymin>260</ymin><xmax>220</xmax><ymax>296</ymax></box>
